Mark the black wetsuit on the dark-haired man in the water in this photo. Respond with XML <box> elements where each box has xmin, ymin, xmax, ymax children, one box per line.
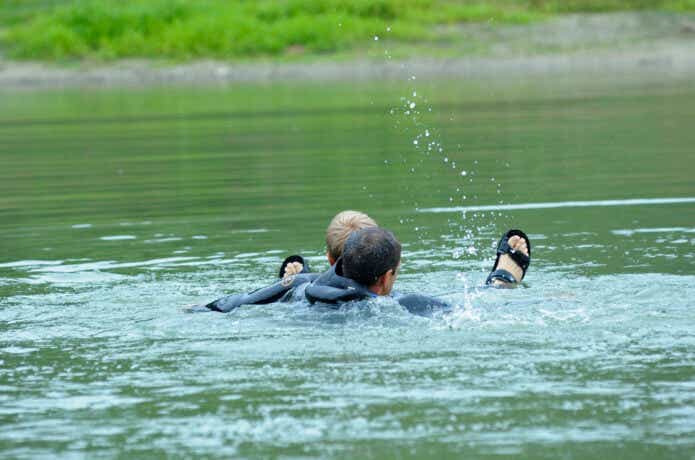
<box><xmin>205</xmin><ymin>259</ymin><xmax>452</xmax><ymax>316</ymax></box>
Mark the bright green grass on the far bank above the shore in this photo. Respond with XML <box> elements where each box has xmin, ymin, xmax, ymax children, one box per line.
<box><xmin>0</xmin><ymin>0</ymin><xmax>695</xmax><ymax>61</ymax></box>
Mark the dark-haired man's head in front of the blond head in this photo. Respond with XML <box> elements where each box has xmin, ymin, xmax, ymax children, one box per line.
<box><xmin>343</xmin><ymin>227</ymin><xmax>401</xmax><ymax>295</ymax></box>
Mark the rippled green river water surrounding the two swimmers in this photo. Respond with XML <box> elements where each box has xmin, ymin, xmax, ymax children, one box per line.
<box><xmin>0</xmin><ymin>73</ymin><xmax>695</xmax><ymax>459</ymax></box>
